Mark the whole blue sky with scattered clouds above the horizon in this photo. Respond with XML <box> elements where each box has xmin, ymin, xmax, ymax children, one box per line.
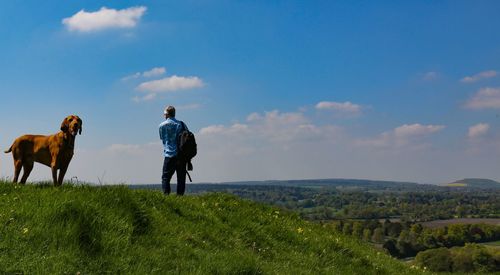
<box><xmin>0</xmin><ymin>1</ymin><xmax>500</xmax><ymax>183</ymax></box>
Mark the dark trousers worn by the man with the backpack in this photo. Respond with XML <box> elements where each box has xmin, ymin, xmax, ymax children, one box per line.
<box><xmin>161</xmin><ymin>157</ymin><xmax>186</xmax><ymax>196</ymax></box>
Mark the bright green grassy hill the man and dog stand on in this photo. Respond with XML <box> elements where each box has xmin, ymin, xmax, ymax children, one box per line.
<box><xmin>0</xmin><ymin>182</ymin><xmax>419</xmax><ymax>274</ymax></box>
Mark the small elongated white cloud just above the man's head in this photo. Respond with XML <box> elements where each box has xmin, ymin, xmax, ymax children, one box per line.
<box><xmin>136</xmin><ymin>75</ymin><xmax>205</xmax><ymax>93</ymax></box>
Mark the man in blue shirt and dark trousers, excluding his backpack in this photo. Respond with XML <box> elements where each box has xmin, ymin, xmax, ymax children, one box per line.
<box><xmin>160</xmin><ymin>106</ymin><xmax>188</xmax><ymax>196</ymax></box>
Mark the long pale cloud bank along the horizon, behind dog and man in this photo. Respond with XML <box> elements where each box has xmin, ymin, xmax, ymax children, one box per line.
<box><xmin>0</xmin><ymin>105</ymin><xmax>500</xmax><ymax>185</ymax></box>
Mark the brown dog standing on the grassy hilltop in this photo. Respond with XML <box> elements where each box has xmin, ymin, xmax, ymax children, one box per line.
<box><xmin>5</xmin><ymin>115</ymin><xmax>82</xmax><ymax>186</ymax></box>
